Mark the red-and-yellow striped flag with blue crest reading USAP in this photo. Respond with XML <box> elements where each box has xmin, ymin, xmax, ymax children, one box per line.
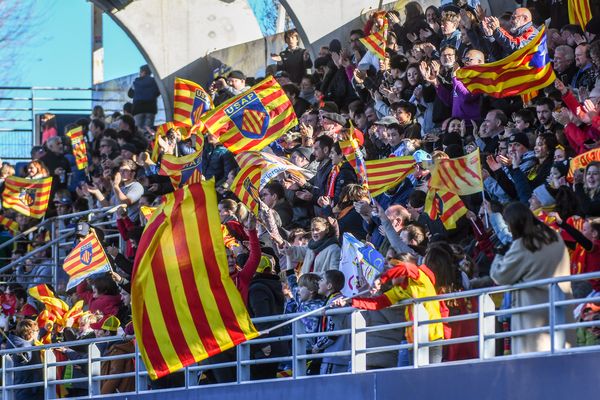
<box><xmin>202</xmin><ymin>77</ymin><xmax>298</xmax><ymax>154</ymax></box>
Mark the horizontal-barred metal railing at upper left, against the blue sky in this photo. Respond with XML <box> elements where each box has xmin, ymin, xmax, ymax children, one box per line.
<box><xmin>0</xmin><ymin>86</ymin><xmax>129</xmax><ymax>161</ymax></box>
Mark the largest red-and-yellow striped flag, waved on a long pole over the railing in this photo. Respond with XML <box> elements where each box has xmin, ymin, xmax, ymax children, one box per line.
<box><xmin>131</xmin><ymin>181</ymin><xmax>258</xmax><ymax>379</ymax></box>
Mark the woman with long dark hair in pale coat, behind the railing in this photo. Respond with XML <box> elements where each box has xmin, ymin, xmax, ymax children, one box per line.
<box><xmin>490</xmin><ymin>203</ymin><xmax>571</xmax><ymax>354</ymax></box>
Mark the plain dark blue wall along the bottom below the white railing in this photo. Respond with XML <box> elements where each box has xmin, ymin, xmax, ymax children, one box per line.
<box><xmin>104</xmin><ymin>352</ymin><xmax>600</xmax><ymax>400</ymax></box>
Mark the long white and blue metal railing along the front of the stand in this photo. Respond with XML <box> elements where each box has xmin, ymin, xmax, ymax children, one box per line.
<box><xmin>0</xmin><ymin>272</ymin><xmax>600</xmax><ymax>400</ymax></box>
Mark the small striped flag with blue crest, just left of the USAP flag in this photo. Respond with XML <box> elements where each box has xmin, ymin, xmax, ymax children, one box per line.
<box><xmin>173</xmin><ymin>78</ymin><xmax>213</xmax><ymax>126</ymax></box>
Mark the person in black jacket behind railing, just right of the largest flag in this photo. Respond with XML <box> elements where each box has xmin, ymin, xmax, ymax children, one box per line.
<box><xmin>248</xmin><ymin>255</ymin><xmax>287</xmax><ymax>380</ymax></box>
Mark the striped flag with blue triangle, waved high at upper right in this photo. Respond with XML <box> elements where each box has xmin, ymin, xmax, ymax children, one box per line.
<box><xmin>456</xmin><ymin>27</ymin><xmax>556</xmax><ymax>98</ymax></box>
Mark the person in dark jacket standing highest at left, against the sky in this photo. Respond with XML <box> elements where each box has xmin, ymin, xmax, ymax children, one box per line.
<box><xmin>127</xmin><ymin>65</ymin><xmax>160</xmax><ymax>130</ymax></box>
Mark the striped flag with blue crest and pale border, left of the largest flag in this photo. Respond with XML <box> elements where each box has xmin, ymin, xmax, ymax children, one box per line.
<box><xmin>63</xmin><ymin>231</ymin><xmax>111</xmax><ymax>290</ymax></box>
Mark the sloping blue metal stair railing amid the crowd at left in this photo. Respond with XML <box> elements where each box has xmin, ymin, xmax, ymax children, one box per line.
<box><xmin>0</xmin><ymin>206</ymin><xmax>124</xmax><ymax>288</ymax></box>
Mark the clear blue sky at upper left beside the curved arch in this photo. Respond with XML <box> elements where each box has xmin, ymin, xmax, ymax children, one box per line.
<box><xmin>14</xmin><ymin>0</ymin><xmax>145</xmax><ymax>87</ymax></box>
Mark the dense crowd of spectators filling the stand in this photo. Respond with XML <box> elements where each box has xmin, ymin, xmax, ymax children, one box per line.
<box><xmin>0</xmin><ymin>0</ymin><xmax>600</xmax><ymax>398</ymax></box>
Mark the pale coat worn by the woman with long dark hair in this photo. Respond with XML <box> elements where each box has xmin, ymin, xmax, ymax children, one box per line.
<box><xmin>490</xmin><ymin>234</ymin><xmax>571</xmax><ymax>354</ymax></box>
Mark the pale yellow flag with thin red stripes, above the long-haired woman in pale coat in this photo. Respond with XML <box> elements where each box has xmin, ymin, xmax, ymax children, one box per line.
<box><xmin>429</xmin><ymin>149</ymin><xmax>483</xmax><ymax>196</ymax></box>
